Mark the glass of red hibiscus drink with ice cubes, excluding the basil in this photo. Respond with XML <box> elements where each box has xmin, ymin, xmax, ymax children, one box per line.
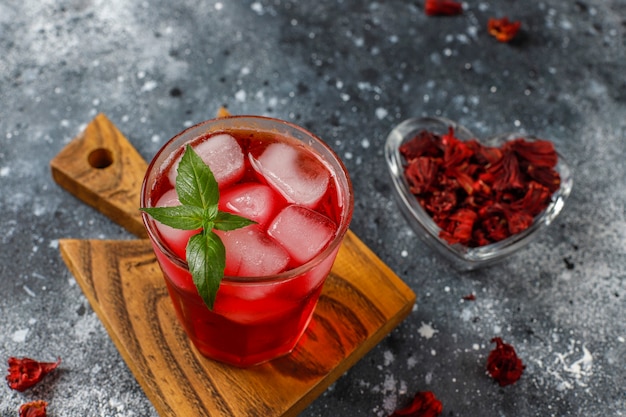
<box><xmin>141</xmin><ymin>116</ymin><xmax>353</xmax><ymax>366</ymax></box>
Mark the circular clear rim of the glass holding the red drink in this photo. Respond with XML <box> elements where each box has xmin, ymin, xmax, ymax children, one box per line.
<box><xmin>140</xmin><ymin>115</ymin><xmax>354</xmax><ymax>284</ymax></box>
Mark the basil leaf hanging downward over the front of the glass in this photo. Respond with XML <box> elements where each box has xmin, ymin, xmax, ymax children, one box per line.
<box><xmin>187</xmin><ymin>230</ymin><xmax>226</xmax><ymax>310</ymax></box>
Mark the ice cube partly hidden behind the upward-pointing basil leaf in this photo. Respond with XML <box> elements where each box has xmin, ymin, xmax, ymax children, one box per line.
<box><xmin>168</xmin><ymin>133</ymin><xmax>245</xmax><ymax>188</ymax></box>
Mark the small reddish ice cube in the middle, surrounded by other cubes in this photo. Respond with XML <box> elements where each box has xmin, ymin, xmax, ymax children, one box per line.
<box><xmin>219</xmin><ymin>183</ymin><xmax>284</xmax><ymax>227</ymax></box>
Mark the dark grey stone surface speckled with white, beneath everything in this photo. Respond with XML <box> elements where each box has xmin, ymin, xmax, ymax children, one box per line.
<box><xmin>0</xmin><ymin>0</ymin><xmax>626</xmax><ymax>417</ymax></box>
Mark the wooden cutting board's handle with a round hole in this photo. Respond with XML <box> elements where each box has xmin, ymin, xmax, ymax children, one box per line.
<box><xmin>50</xmin><ymin>114</ymin><xmax>148</xmax><ymax>238</ymax></box>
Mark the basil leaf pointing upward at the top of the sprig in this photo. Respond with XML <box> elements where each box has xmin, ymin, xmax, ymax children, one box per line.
<box><xmin>176</xmin><ymin>145</ymin><xmax>220</xmax><ymax>209</ymax></box>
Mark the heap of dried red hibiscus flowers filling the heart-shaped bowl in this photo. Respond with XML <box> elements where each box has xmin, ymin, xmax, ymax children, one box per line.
<box><xmin>399</xmin><ymin>128</ymin><xmax>561</xmax><ymax>247</ymax></box>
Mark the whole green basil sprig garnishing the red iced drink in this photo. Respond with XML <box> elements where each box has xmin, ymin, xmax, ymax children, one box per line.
<box><xmin>141</xmin><ymin>145</ymin><xmax>255</xmax><ymax>310</ymax></box>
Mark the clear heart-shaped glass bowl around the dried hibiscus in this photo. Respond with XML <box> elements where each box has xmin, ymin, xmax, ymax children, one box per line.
<box><xmin>385</xmin><ymin>117</ymin><xmax>573</xmax><ymax>270</ymax></box>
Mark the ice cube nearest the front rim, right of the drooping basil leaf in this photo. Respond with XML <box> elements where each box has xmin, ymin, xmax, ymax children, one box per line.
<box><xmin>217</xmin><ymin>225</ymin><xmax>290</xmax><ymax>277</ymax></box>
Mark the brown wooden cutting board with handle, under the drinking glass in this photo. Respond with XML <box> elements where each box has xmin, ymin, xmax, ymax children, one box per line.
<box><xmin>50</xmin><ymin>114</ymin><xmax>415</xmax><ymax>417</ymax></box>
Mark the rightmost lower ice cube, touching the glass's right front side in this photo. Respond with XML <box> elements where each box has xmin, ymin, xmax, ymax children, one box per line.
<box><xmin>267</xmin><ymin>205</ymin><xmax>337</xmax><ymax>263</ymax></box>
